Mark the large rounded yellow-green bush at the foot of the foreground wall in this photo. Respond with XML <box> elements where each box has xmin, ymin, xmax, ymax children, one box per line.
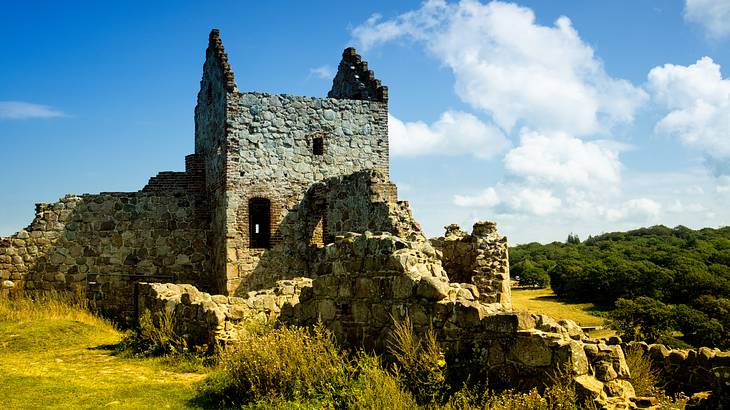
<box><xmin>198</xmin><ymin>325</ymin><xmax>353</xmax><ymax>405</ymax></box>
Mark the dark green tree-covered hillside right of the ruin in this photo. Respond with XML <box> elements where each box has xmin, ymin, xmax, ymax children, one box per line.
<box><xmin>510</xmin><ymin>226</ymin><xmax>730</xmax><ymax>347</ymax></box>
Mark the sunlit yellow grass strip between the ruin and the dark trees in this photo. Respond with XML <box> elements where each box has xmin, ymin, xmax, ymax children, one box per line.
<box><xmin>512</xmin><ymin>289</ymin><xmax>615</xmax><ymax>337</ymax></box>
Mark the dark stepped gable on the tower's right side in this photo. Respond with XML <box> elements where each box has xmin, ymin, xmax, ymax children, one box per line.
<box><xmin>327</xmin><ymin>47</ymin><xmax>388</xmax><ymax>103</ymax></box>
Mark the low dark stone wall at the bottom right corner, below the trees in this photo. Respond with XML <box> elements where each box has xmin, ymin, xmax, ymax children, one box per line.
<box><xmin>624</xmin><ymin>342</ymin><xmax>730</xmax><ymax>397</ymax></box>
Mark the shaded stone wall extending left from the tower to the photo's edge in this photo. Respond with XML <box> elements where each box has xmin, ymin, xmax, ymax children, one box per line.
<box><xmin>0</xmin><ymin>192</ymin><xmax>211</xmax><ymax>319</ymax></box>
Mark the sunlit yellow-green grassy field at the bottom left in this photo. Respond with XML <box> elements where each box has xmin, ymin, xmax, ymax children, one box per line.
<box><xmin>0</xmin><ymin>294</ymin><xmax>205</xmax><ymax>409</ymax></box>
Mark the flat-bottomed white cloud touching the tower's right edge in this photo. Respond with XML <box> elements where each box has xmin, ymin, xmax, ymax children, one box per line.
<box><xmin>388</xmin><ymin>111</ymin><xmax>510</xmax><ymax>159</ymax></box>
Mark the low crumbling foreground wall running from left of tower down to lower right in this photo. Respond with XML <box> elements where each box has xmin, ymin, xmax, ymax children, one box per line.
<box><xmin>140</xmin><ymin>232</ymin><xmax>634</xmax><ymax>408</ymax></box>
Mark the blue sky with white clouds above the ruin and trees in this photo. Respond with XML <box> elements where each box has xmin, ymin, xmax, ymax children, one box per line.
<box><xmin>0</xmin><ymin>0</ymin><xmax>730</xmax><ymax>244</ymax></box>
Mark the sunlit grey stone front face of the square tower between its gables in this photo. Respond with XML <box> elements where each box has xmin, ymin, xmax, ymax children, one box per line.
<box><xmin>226</xmin><ymin>93</ymin><xmax>388</xmax><ymax>292</ymax></box>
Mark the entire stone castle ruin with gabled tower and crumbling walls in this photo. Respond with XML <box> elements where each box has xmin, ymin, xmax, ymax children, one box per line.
<box><xmin>0</xmin><ymin>30</ymin><xmax>648</xmax><ymax>403</ymax></box>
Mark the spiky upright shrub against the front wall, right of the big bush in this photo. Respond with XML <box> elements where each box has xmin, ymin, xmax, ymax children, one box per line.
<box><xmin>388</xmin><ymin>317</ymin><xmax>448</xmax><ymax>404</ymax></box>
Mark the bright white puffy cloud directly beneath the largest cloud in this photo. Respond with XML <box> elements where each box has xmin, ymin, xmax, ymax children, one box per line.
<box><xmin>504</xmin><ymin>132</ymin><xmax>622</xmax><ymax>189</ymax></box>
